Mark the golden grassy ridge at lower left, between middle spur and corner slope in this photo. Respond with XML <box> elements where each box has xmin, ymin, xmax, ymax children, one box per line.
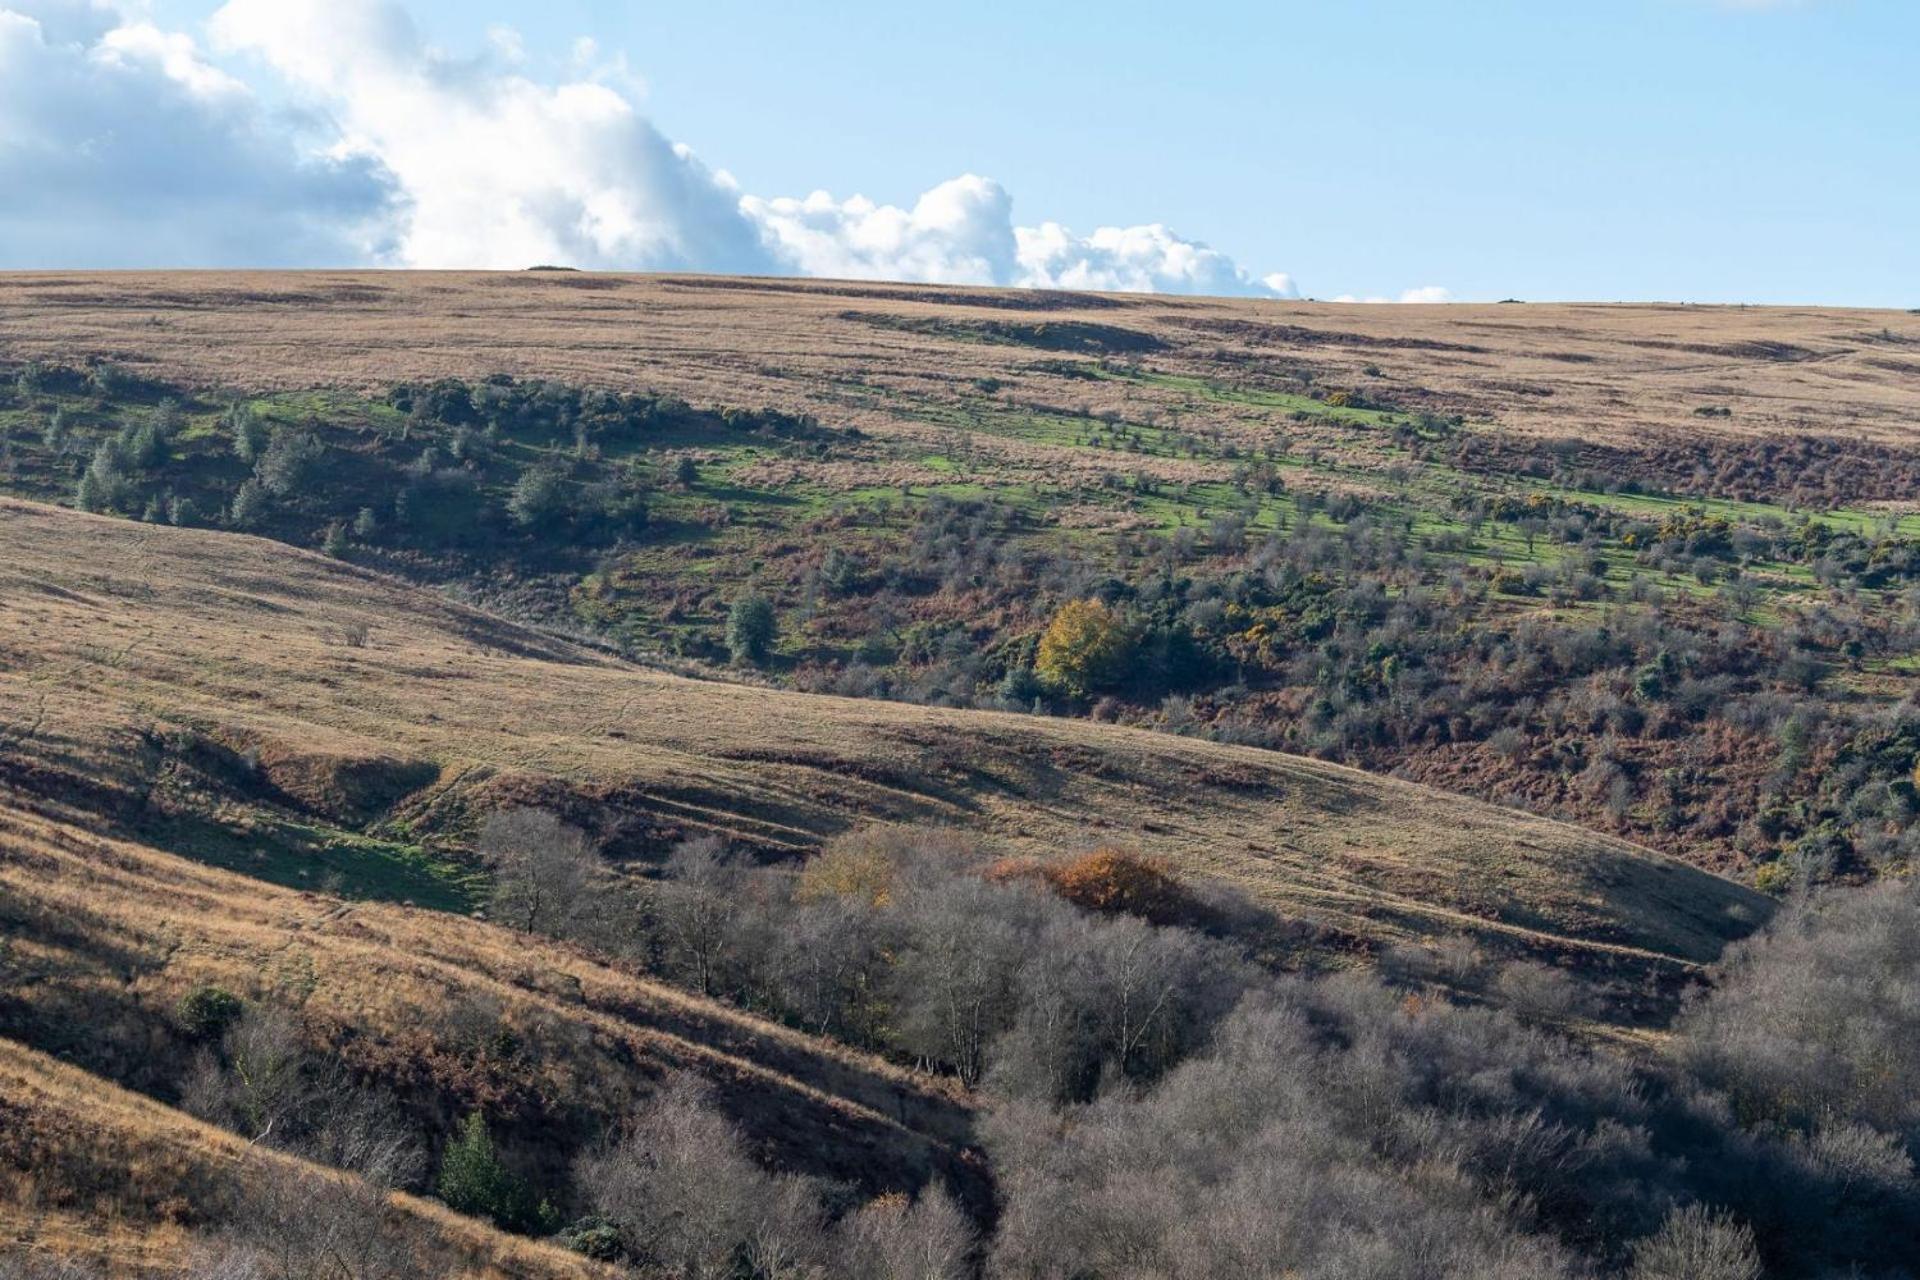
<box><xmin>0</xmin><ymin>804</ymin><xmax>970</xmax><ymax>1190</ymax></box>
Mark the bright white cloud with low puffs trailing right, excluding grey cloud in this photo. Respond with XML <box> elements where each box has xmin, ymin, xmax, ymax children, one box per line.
<box><xmin>213</xmin><ymin>0</ymin><xmax>1292</xmax><ymax>296</ymax></box>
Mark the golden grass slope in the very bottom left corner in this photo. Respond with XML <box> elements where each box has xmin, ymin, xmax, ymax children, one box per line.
<box><xmin>0</xmin><ymin>1038</ymin><xmax>614</xmax><ymax>1280</ymax></box>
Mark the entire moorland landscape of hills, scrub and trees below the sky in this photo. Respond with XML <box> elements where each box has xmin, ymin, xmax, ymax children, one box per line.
<box><xmin>0</xmin><ymin>273</ymin><xmax>1920</xmax><ymax>1280</ymax></box>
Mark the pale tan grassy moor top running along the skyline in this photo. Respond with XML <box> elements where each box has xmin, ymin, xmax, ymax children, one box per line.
<box><xmin>0</xmin><ymin>273</ymin><xmax>1920</xmax><ymax>447</ymax></box>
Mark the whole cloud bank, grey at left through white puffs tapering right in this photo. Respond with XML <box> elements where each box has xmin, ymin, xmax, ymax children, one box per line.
<box><xmin>0</xmin><ymin>0</ymin><xmax>1436</xmax><ymax>297</ymax></box>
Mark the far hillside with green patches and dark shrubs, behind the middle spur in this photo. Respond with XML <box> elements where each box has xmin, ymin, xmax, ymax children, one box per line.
<box><xmin>0</xmin><ymin>273</ymin><xmax>1920</xmax><ymax>890</ymax></box>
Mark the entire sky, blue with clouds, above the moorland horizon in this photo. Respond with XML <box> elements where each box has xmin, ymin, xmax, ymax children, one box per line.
<box><xmin>0</xmin><ymin>0</ymin><xmax>1920</xmax><ymax>307</ymax></box>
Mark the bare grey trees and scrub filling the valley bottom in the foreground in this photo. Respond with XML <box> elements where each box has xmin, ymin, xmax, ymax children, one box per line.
<box><xmin>18</xmin><ymin>814</ymin><xmax>1920</xmax><ymax>1280</ymax></box>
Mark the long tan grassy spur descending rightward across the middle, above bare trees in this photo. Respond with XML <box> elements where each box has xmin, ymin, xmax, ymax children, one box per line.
<box><xmin>0</xmin><ymin>501</ymin><xmax>1768</xmax><ymax>967</ymax></box>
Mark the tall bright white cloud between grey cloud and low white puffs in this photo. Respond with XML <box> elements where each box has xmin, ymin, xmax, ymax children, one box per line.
<box><xmin>211</xmin><ymin>0</ymin><xmax>778</xmax><ymax>273</ymax></box>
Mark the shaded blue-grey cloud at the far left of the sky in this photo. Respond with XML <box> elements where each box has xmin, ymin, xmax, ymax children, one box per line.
<box><xmin>0</xmin><ymin>0</ymin><xmax>392</xmax><ymax>269</ymax></box>
